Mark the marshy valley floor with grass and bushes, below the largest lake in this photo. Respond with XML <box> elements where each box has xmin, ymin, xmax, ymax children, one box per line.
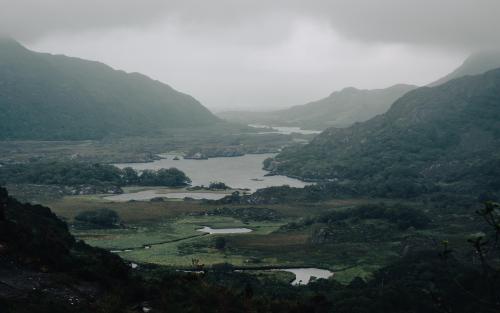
<box><xmin>44</xmin><ymin>189</ymin><xmax>478</xmax><ymax>276</ymax></box>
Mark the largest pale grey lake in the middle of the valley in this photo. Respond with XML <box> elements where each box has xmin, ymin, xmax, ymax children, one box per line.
<box><xmin>113</xmin><ymin>153</ymin><xmax>308</xmax><ymax>191</ymax></box>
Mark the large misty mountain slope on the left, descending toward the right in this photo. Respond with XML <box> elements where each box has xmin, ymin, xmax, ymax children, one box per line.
<box><xmin>0</xmin><ymin>38</ymin><xmax>219</xmax><ymax>140</ymax></box>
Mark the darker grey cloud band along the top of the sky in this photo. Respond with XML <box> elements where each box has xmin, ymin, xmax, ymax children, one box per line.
<box><xmin>0</xmin><ymin>0</ymin><xmax>500</xmax><ymax>49</ymax></box>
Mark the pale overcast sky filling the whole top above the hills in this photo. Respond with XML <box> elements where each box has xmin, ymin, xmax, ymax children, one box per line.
<box><xmin>0</xmin><ymin>0</ymin><xmax>500</xmax><ymax>111</ymax></box>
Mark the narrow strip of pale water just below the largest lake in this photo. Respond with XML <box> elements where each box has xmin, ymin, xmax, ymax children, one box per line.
<box><xmin>104</xmin><ymin>189</ymin><xmax>228</xmax><ymax>202</ymax></box>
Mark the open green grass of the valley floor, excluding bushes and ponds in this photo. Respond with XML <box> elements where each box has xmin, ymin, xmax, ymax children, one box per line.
<box><xmin>33</xmin><ymin>190</ymin><xmax>482</xmax><ymax>283</ymax></box>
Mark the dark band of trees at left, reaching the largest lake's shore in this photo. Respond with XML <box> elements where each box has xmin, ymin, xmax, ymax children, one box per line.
<box><xmin>0</xmin><ymin>161</ymin><xmax>191</xmax><ymax>187</ymax></box>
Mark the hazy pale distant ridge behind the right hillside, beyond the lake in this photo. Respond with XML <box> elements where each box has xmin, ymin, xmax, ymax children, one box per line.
<box><xmin>218</xmin><ymin>84</ymin><xmax>417</xmax><ymax>129</ymax></box>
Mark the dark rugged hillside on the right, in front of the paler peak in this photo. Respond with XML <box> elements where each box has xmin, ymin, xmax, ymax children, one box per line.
<box><xmin>267</xmin><ymin>69</ymin><xmax>500</xmax><ymax>197</ymax></box>
